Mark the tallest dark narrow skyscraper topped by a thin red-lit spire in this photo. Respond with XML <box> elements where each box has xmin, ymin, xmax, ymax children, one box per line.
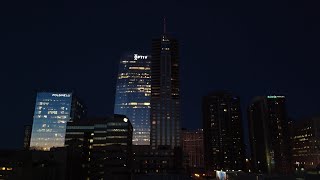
<box><xmin>151</xmin><ymin>24</ymin><xmax>181</xmax><ymax>149</ymax></box>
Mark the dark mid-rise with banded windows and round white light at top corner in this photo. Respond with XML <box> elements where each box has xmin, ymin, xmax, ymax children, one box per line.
<box><xmin>65</xmin><ymin>115</ymin><xmax>133</xmax><ymax>179</ymax></box>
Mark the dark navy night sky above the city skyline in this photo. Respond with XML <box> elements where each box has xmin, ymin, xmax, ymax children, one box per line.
<box><xmin>0</xmin><ymin>0</ymin><xmax>320</xmax><ymax>148</ymax></box>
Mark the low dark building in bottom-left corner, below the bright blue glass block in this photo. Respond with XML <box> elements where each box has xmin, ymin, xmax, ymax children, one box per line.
<box><xmin>0</xmin><ymin>148</ymin><xmax>76</xmax><ymax>180</ymax></box>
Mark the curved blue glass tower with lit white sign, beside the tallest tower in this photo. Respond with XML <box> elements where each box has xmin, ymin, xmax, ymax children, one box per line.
<box><xmin>114</xmin><ymin>53</ymin><xmax>151</xmax><ymax>145</ymax></box>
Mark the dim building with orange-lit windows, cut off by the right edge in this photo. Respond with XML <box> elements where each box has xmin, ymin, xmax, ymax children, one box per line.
<box><xmin>292</xmin><ymin>117</ymin><xmax>320</xmax><ymax>170</ymax></box>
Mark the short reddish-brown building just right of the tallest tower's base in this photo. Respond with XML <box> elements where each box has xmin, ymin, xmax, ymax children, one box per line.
<box><xmin>181</xmin><ymin>129</ymin><xmax>204</xmax><ymax>168</ymax></box>
